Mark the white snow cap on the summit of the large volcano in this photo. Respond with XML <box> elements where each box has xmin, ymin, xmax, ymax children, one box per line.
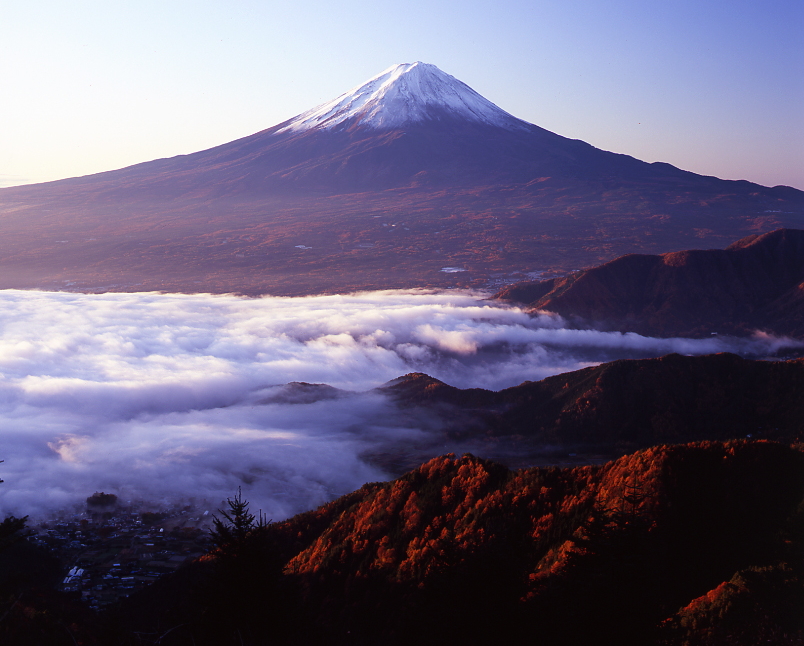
<box><xmin>279</xmin><ymin>61</ymin><xmax>527</xmax><ymax>132</ymax></box>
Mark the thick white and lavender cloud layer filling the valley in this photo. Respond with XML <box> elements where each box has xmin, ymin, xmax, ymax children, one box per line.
<box><xmin>0</xmin><ymin>290</ymin><xmax>789</xmax><ymax>520</ymax></box>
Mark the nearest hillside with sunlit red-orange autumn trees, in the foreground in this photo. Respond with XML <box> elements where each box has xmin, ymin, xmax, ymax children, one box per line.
<box><xmin>97</xmin><ymin>441</ymin><xmax>804</xmax><ymax>646</ymax></box>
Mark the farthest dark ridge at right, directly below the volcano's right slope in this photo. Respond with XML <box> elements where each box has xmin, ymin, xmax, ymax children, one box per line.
<box><xmin>496</xmin><ymin>229</ymin><xmax>804</xmax><ymax>337</ymax></box>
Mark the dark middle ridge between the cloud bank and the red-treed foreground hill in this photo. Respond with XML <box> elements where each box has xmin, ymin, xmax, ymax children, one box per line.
<box><xmin>378</xmin><ymin>353</ymin><xmax>804</xmax><ymax>471</ymax></box>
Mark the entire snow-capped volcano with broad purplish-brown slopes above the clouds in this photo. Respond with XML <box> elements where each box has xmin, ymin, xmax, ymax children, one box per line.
<box><xmin>0</xmin><ymin>62</ymin><xmax>804</xmax><ymax>294</ymax></box>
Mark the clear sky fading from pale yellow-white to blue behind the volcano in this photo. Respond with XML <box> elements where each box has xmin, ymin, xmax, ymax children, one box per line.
<box><xmin>0</xmin><ymin>0</ymin><xmax>804</xmax><ymax>189</ymax></box>
